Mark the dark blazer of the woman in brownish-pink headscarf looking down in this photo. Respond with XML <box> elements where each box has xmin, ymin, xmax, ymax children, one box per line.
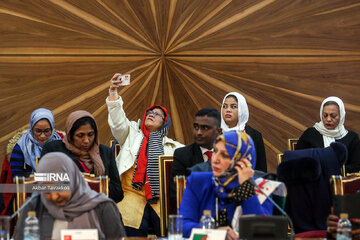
<box><xmin>40</xmin><ymin>140</ymin><xmax>124</xmax><ymax>202</ymax></box>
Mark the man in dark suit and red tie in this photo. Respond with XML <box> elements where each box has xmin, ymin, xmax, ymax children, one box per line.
<box><xmin>170</xmin><ymin>108</ymin><xmax>221</xmax><ymax>213</ymax></box>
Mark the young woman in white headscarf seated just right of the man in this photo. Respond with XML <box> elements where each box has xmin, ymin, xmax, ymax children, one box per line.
<box><xmin>221</xmin><ymin>92</ymin><xmax>267</xmax><ymax>172</ymax></box>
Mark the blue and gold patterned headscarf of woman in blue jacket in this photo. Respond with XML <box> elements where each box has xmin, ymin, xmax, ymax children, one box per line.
<box><xmin>216</xmin><ymin>131</ymin><xmax>256</xmax><ymax>178</ymax></box>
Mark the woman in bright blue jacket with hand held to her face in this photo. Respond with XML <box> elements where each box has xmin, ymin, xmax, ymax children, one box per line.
<box><xmin>179</xmin><ymin>131</ymin><xmax>273</xmax><ymax>239</ymax></box>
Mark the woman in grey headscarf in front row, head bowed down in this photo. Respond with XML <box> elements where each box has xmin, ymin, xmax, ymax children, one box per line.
<box><xmin>13</xmin><ymin>152</ymin><xmax>126</xmax><ymax>239</ymax></box>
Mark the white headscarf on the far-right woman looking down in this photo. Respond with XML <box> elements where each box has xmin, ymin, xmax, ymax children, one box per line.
<box><xmin>314</xmin><ymin>96</ymin><xmax>348</xmax><ymax>147</ymax></box>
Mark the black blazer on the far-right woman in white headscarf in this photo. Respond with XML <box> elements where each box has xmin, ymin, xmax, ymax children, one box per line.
<box><xmin>296</xmin><ymin>127</ymin><xmax>360</xmax><ymax>173</ymax></box>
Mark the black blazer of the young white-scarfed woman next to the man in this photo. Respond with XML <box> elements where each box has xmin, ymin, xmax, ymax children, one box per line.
<box><xmin>245</xmin><ymin>125</ymin><xmax>267</xmax><ymax>172</ymax></box>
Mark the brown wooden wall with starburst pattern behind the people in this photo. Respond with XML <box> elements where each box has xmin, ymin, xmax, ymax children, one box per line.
<box><xmin>0</xmin><ymin>0</ymin><xmax>360</xmax><ymax>171</ymax></box>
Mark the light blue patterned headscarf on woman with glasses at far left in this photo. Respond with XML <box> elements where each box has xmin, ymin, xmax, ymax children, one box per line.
<box><xmin>17</xmin><ymin>108</ymin><xmax>61</xmax><ymax>170</ymax></box>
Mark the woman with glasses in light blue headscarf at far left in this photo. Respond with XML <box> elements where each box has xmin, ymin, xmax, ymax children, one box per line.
<box><xmin>10</xmin><ymin>108</ymin><xmax>64</xmax><ymax>178</ymax></box>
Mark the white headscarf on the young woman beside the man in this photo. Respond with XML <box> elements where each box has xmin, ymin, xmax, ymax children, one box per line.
<box><xmin>221</xmin><ymin>92</ymin><xmax>249</xmax><ymax>132</ymax></box>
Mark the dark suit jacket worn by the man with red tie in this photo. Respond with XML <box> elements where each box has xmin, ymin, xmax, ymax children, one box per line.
<box><xmin>170</xmin><ymin>143</ymin><xmax>204</xmax><ymax>213</ymax></box>
